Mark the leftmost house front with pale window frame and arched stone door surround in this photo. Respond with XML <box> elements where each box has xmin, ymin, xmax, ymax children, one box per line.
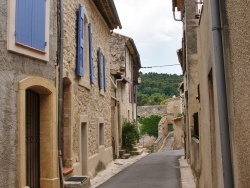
<box><xmin>0</xmin><ymin>0</ymin><xmax>59</xmax><ymax>187</ymax></box>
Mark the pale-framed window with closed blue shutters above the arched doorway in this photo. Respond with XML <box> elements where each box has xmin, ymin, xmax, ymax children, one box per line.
<box><xmin>8</xmin><ymin>0</ymin><xmax>50</xmax><ymax>61</ymax></box>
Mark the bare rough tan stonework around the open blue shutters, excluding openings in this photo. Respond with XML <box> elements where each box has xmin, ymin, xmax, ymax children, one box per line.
<box><xmin>64</xmin><ymin>0</ymin><xmax>113</xmax><ymax>175</ymax></box>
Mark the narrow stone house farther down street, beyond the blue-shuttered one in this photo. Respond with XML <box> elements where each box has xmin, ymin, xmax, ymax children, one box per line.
<box><xmin>109</xmin><ymin>33</ymin><xmax>141</xmax><ymax>157</ymax></box>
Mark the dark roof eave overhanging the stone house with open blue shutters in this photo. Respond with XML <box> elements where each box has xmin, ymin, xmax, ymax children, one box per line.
<box><xmin>93</xmin><ymin>0</ymin><xmax>122</xmax><ymax>30</ymax></box>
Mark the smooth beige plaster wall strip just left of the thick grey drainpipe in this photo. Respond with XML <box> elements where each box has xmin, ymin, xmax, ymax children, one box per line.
<box><xmin>197</xmin><ymin>1</ymin><xmax>224</xmax><ymax>187</ymax></box>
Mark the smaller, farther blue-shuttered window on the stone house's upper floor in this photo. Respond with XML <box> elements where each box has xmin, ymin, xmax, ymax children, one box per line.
<box><xmin>97</xmin><ymin>48</ymin><xmax>107</xmax><ymax>91</ymax></box>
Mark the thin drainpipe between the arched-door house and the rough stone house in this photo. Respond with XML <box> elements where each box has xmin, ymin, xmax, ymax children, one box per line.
<box><xmin>58</xmin><ymin>0</ymin><xmax>64</xmax><ymax>188</ymax></box>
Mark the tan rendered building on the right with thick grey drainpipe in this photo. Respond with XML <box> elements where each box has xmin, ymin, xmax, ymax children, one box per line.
<box><xmin>173</xmin><ymin>0</ymin><xmax>250</xmax><ymax>188</ymax></box>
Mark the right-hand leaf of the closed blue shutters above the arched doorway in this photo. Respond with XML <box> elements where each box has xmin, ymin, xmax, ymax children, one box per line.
<box><xmin>32</xmin><ymin>0</ymin><xmax>46</xmax><ymax>51</ymax></box>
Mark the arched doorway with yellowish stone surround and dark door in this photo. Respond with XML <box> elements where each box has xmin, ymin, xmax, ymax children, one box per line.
<box><xmin>18</xmin><ymin>76</ymin><xmax>59</xmax><ymax>188</ymax></box>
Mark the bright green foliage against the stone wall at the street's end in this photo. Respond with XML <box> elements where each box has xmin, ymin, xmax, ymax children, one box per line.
<box><xmin>139</xmin><ymin>115</ymin><xmax>161</xmax><ymax>138</ymax></box>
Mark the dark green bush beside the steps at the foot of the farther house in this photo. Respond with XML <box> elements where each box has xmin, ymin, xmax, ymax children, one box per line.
<box><xmin>122</xmin><ymin>122</ymin><xmax>139</xmax><ymax>151</ymax></box>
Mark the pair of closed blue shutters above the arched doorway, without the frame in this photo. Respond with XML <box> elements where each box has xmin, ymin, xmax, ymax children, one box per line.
<box><xmin>15</xmin><ymin>0</ymin><xmax>46</xmax><ymax>51</ymax></box>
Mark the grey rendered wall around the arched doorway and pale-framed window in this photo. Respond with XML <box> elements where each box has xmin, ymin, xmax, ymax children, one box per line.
<box><xmin>0</xmin><ymin>0</ymin><xmax>57</xmax><ymax>187</ymax></box>
